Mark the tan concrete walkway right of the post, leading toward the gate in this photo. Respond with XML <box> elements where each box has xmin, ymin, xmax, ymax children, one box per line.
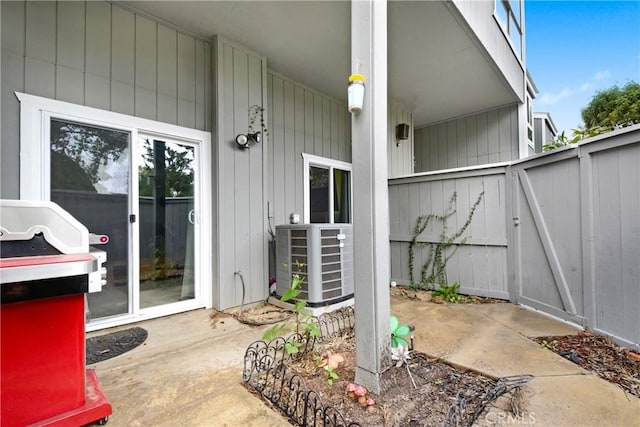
<box><xmin>392</xmin><ymin>298</ymin><xmax>640</xmax><ymax>427</ymax></box>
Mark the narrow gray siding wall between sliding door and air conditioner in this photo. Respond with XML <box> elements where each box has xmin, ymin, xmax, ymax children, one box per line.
<box><xmin>213</xmin><ymin>37</ymin><xmax>270</xmax><ymax>309</ymax></box>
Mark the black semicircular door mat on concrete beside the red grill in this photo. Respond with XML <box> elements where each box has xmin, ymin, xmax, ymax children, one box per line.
<box><xmin>86</xmin><ymin>327</ymin><xmax>148</xmax><ymax>365</ymax></box>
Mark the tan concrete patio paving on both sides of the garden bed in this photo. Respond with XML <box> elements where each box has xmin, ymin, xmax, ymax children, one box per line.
<box><xmin>89</xmin><ymin>297</ymin><xmax>640</xmax><ymax>427</ymax></box>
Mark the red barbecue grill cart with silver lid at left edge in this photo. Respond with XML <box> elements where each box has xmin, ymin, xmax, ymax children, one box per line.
<box><xmin>0</xmin><ymin>200</ymin><xmax>112</xmax><ymax>427</ymax></box>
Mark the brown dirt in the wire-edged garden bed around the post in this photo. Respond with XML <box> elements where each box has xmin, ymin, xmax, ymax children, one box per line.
<box><xmin>289</xmin><ymin>335</ymin><xmax>526</xmax><ymax>427</ymax></box>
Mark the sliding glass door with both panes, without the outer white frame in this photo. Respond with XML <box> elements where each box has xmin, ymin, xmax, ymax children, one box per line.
<box><xmin>49</xmin><ymin>118</ymin><xmax>202</xmax><ymax>323</ymax></box>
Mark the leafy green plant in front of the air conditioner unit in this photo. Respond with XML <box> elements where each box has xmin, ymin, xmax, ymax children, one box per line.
<box><xmin>262</xmin><ymin>263</ymin><xmax>320</xmax><ymax>355</ymax></box>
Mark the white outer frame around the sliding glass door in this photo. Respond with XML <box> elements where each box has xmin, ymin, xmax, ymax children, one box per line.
<box><xmin>15</xmin><ymin>92</ymin><xmax>213</xmax><ymax>330</ymax></box>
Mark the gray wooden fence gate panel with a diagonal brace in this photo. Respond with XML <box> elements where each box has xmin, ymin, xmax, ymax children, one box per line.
<box><xmin>511</xmin><ymin>150</ymin><xmax>584</xmax><ymax>324</ymax></box>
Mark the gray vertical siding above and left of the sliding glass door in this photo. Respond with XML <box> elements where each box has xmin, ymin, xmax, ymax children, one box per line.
<box><xmin>0</xmin><ymin>1</ymin><xmax>212</xmax><ymax>199</ymax></box>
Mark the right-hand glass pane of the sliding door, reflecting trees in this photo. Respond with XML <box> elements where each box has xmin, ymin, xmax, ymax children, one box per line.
<box><xmin>137</xmin><ymin>136</ymin><xmax>196</xmax><ymax>309</ymax></box>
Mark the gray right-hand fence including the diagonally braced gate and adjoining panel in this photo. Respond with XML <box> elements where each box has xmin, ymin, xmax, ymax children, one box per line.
<box><xmin>507</xmin><ymin>130</ymin><xmax>640</xmax><ymax>349</ymax></box>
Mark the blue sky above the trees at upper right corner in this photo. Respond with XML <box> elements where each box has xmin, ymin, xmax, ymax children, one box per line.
<box><xmin>525</xmin><ymin>0</ymin><xmax>640</xmax><ymax>135</ymax></box>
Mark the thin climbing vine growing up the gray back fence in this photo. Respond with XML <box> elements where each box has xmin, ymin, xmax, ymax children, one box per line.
<box><xmin>408</xmin><ymin>191</ymin><xmax>484</xmax><ymax>289</ymax></box>
